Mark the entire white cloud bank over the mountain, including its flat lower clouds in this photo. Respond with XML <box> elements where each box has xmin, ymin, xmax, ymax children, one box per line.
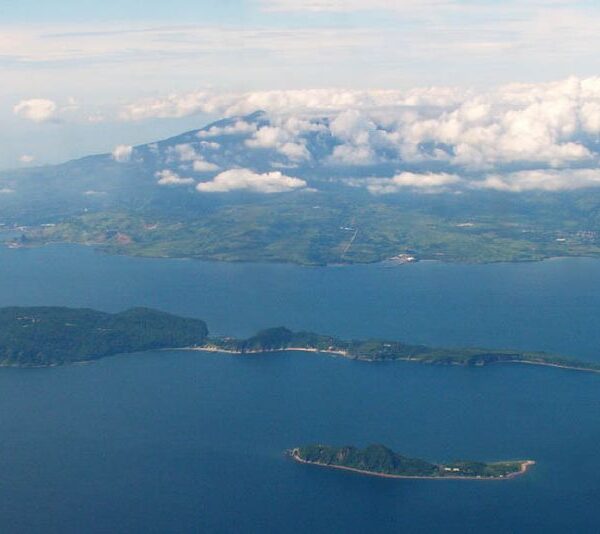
<box><xmin>112</xmin><ymin>77</ymin><xmax>600</xmax><ymax>195</ymax></box>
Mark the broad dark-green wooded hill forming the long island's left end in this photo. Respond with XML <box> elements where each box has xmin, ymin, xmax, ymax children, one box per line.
<box><xmin>0</xmin><ymin>307</ymin><xmax>208</xmax><ymax>367</ymax></box>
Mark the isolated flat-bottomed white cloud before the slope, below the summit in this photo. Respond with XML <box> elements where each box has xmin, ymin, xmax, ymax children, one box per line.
<box><xmin>196</xmin><ymin>169</ymin><xmax>306</xmax><ymax>193</ymax></box>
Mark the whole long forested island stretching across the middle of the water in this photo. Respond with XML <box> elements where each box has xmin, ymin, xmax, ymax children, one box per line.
<box><xmin>0</xmin><ymin>307</ymin><xmax>600</xmax><ymax>372</ymax></box>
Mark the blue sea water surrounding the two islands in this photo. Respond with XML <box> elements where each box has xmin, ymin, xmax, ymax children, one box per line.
<box><xmin>0</xmin><ymin>246</ymin><xmax>600</xmax><ymax>533</ymax></box>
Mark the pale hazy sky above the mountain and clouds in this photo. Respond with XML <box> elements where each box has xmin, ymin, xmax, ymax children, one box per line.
<box><xmin>0</xmin><ymin>0</ymin><xmax>600</xmax><ymax>168</ymax></box>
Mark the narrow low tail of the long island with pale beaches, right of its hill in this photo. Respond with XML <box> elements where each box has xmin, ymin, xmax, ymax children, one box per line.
<box><xmin>205</xmin><ymin>327</ymin><xmax>600</xmax><ymax>372</ymax></box>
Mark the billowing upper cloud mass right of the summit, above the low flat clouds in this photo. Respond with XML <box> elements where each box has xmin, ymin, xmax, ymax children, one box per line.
<box><xmin>129</xmin><ymin>77</ymin><xmax>600</xmax><ymax>171</ymax></box>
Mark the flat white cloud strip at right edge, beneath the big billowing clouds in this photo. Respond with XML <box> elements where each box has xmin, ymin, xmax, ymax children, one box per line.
<box><xmin>471</xmin><ymin>169</ymin><xmax>600</xmax><ymax>193</ymax></box>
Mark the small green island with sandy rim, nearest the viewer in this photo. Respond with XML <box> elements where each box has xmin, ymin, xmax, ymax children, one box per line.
<box><xmin>288</xmin><ymin>444</ymin><xmax>535</xmax><ymax>480</ymax></box>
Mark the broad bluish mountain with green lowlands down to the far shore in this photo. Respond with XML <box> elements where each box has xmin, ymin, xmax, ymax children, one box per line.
<box><xmin>0</xmin><ymin>112</ymin><xmax>600</xmax><ymax>265</ymax></box>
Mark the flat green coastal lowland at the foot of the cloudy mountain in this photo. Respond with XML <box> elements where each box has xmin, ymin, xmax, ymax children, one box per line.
<box><xmin>22</xmin><ymin>191</ymin><xmax>600</xmax><ymax>265</ymax></box>
